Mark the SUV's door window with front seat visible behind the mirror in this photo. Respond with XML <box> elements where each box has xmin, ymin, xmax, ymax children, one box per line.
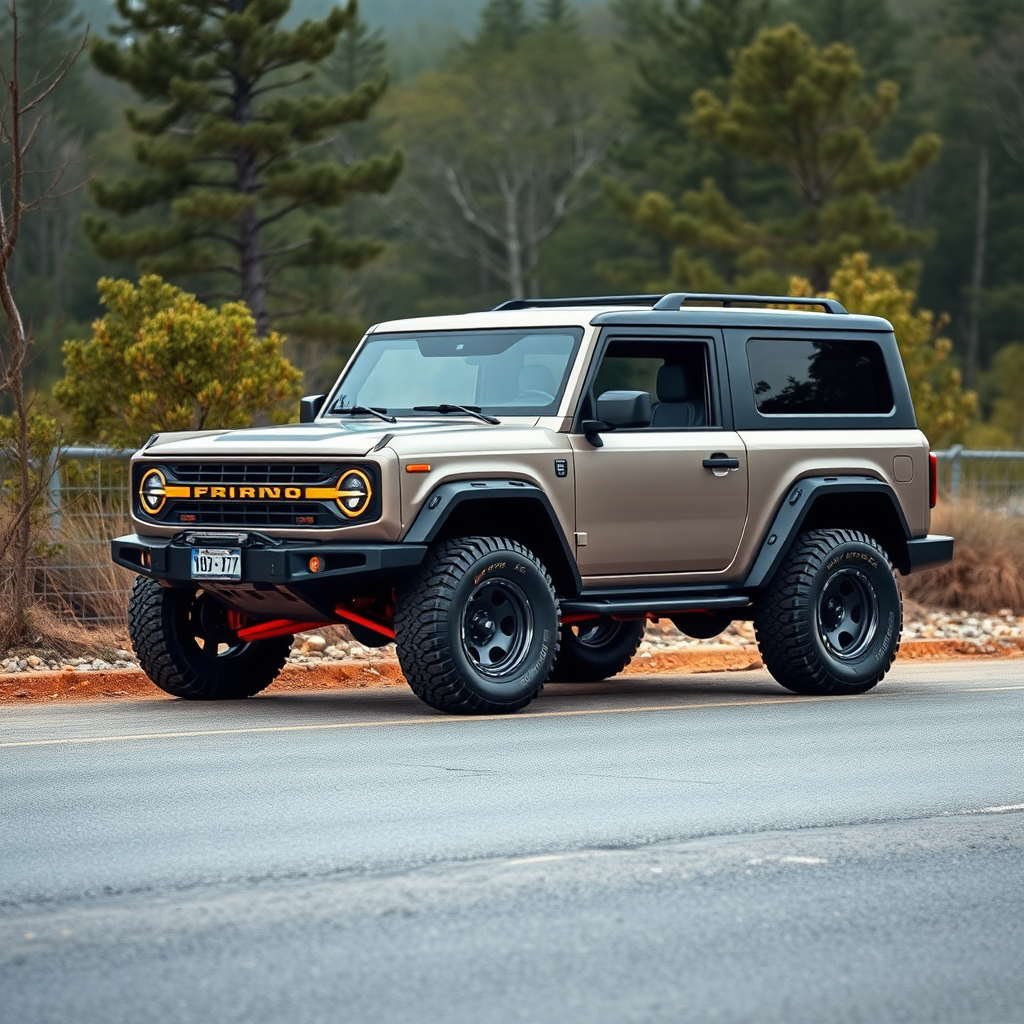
<box><xmin>589</xmin><ymin>339</ymin><xmax>713</xmax><ymax>430</ymax></box>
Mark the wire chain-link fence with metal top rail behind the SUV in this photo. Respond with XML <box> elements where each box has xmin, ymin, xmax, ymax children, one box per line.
<box><xmin>0</xmin><ymin>445</ymin><xmax>1024</xmax><ymax>624</ymax></box>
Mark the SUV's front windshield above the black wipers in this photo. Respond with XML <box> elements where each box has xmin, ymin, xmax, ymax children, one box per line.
<box><xmin>327</xmin><ymin>328</ymin><xmax>583</xmax><ymax>416</ymax></box>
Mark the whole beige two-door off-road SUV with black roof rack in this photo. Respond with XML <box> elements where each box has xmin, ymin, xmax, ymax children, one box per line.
<box><xmin>113</xmin><ymin>294</ymin><xmax>952</xmax><ymax>714</ymax></box>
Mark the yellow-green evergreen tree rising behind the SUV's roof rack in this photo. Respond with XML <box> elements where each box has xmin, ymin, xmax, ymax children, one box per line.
<box><xmin>616</xmin><ymin>25</ymin><xmax>940</xmax><ymax>292</ymax></box>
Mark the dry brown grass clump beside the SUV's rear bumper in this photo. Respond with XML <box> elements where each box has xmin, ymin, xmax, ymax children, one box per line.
<box><xmin>903</xmin><ymin>500</ymin><xmax>1024</xmax><ymax>613</ymax></box>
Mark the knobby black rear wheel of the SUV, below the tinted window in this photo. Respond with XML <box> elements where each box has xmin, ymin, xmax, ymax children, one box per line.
<box><xmin>754</xmin><ymin>529</ymin><xmax>903</xmax><ymax>694</ymax></box>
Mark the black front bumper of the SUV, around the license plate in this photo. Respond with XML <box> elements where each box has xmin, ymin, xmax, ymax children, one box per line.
<box><xmin>111</xmin><ymin>534</ymin><xmax>427</xmax><ymax>587</ymax></box>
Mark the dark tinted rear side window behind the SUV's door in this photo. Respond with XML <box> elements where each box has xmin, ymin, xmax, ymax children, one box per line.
<box><xmin>746</xmin><ymin>340</ymin><xmax>893</xmax><ymax>416</ymax></box>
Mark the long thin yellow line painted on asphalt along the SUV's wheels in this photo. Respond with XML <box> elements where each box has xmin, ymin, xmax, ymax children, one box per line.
<box><xmin>0</xmin><ymin>685</ymin><xmax>1024</xmax><ymax>750</ymax></box>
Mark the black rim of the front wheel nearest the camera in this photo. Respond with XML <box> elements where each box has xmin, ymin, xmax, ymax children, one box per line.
<box><xmin>462</xmin><ymin>579</ymin><xmax>534</xmax><ymax>678</ymax></box>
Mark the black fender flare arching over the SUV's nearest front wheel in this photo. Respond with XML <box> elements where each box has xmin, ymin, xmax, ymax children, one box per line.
<box><xmin>401</xmin><ymin>479</ymin><xmax>583</xmax><ymax>597</ymax></box>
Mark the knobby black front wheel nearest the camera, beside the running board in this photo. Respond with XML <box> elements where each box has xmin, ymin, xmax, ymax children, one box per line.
<box><xmin>394</xmin><ymin>537</ymin><xmax>559</xmax><ymax>715</ymax></box>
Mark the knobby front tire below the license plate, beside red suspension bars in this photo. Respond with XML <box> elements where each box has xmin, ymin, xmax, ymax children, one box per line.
<box><xmin>128</xmin><ymin>577</ymin><xmax>292</xmax><ymax>700</ymax></box>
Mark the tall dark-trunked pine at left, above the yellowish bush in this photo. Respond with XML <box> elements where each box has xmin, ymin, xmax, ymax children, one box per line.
<box><xmin>85</xmin><ymin>0</ymin><xmax>402</xmax><ymax>336</ymax></box>
